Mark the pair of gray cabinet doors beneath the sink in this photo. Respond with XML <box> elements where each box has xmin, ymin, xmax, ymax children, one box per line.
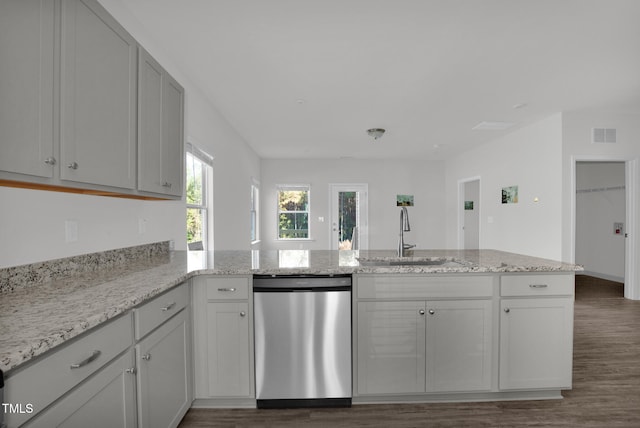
<box><xmin>357</xmin><ymin>300</ymin><xmax>493</xmax><ymax>394</ymax></box>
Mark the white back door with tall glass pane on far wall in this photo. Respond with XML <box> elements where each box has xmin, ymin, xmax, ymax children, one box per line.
<box><xmin>329</xmin><ymin>183</ymin><xmax>369</xmax><ymax>250</ymax></box>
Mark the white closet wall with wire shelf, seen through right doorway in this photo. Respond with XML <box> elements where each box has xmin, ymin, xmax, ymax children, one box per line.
<box><xmin>576</xmin><ymin>162</ymin><xmax>626</xmax><ymax>282</ymax></box>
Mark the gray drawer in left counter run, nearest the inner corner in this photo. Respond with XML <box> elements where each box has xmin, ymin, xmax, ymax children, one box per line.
<box><xmin>134</xmin><ymin>284</ymin><xmax>189</xmax><ymax>340</ymax></box>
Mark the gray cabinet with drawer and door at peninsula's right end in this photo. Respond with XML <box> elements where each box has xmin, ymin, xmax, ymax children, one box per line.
<box><xmin>500</xmin><ymin>274</ymin><xmax>575</xmax><ymax>391</ymax></box>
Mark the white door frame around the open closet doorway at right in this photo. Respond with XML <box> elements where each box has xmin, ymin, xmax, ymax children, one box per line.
<box><xmin>569</xmin><ymin>155</ymin><xmax>640</xmax><ymax>300</ymax></box>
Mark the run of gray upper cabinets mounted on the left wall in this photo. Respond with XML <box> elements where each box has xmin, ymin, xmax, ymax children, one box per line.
<box><xmin>0</xmin><ymin>0</ymin><xmax>184</xmax><ymax>199</ymax></box>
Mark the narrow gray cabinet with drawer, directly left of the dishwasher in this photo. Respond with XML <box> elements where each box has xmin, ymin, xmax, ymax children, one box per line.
<box><xmin>193</xmin><ymin>276</ymin><xmax>255</xmax><ymax>406</ymax></box>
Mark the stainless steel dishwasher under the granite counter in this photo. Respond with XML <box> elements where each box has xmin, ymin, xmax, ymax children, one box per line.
<box><xmin>253</xmin><ymin>275</ymin><xmax>351</xmax><ymax>408</ymax></box>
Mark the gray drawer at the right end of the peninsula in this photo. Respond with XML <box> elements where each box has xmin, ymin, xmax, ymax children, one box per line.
<box><xmin>500</xmin><ymin>274</ymin><xmax>575</xmax><ymax>296</ymax></box>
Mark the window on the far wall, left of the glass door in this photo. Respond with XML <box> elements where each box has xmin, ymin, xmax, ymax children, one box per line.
<box><xmin>278</xmin><ymin>186</ymin><xmax>309</xmax><ymax>239</ymax></box>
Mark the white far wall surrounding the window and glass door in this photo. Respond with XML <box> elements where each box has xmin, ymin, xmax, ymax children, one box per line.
<box><xmin>261</xmin><ymin>159</ymin><xmax>446</xmax><ymax>249</ymax></box>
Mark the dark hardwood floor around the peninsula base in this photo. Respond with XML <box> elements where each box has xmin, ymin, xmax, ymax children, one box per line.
<box><xmin>180</xmin><ymin>275</ymin><xmax>640</xmax><ymax>428</ymax></box>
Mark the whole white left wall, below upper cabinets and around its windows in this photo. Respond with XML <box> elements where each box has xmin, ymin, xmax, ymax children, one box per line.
<box><xmin>0</xmin><ymin>0</ymin><xmax>260</xmax><ymax>267</ymax></box>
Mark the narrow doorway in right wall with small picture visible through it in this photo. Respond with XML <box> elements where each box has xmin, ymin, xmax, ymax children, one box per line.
<box><xmin>458</xmin><ymin>177</ymin><xmax>480</xmax><ymax>250</ymax></box>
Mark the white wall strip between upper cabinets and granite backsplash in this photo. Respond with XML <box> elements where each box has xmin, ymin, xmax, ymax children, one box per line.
<box><xmin>0</xmin><ymin>187</ymin><xmax>185</xmax><ymax>268</ymax></box>
